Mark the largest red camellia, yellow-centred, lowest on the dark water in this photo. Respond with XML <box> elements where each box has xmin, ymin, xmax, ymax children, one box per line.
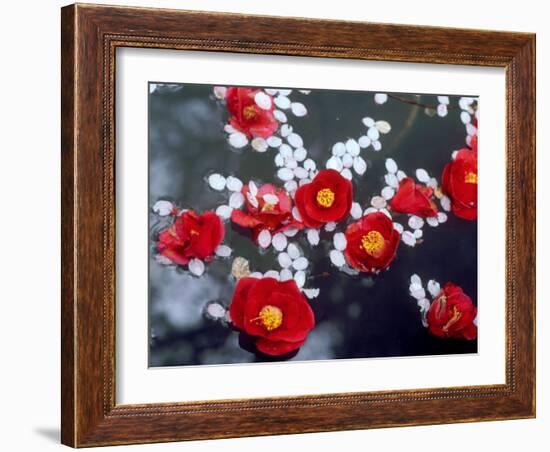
<box><xmin>229</xmin><ymin>278</ymin><xmax>315</xmax><ymax>356</ymax></box>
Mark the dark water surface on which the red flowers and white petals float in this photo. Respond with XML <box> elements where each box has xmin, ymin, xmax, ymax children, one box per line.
<box><xmin>148</xmin><ymin>84</ymin><xmax>477</xmax><ymax>366</ymax></box>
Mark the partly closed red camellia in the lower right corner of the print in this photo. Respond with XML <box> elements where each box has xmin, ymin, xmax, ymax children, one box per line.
<box><xmin>427</xmin><ymin>283</ymin><xmax>477</xmax><ymax>340</ymax></box>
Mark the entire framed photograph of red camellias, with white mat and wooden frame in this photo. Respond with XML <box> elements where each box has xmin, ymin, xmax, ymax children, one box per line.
<box><xmin>62</xmin><ymin>4</ymin><xmax>535</xmax><ymax>447</ymax></box>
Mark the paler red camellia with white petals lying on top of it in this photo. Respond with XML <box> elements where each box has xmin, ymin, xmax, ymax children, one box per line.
<box><xmin>231</xmin><ymin>184</ymin><xmax>303</xmax><ymax>240</ymax></box>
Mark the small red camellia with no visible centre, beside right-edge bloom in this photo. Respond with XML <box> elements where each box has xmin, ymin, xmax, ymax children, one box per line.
<box><xmin>390</xmin><ymin>177</ymin><xmax>437</xmax><ymax>218</ymax></box>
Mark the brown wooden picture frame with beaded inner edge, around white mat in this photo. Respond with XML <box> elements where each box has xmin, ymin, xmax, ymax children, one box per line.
<box><xmin>61</xmin><ymin>4</ymin><xmax>535</xmax><ymax>447</ymax></box>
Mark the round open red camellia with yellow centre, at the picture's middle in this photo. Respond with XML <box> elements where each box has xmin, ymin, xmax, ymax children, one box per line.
<box><xmin>294</xmin><ymin>169</ymin><xmax>353</xmax><ymax>228</ymax></box>
